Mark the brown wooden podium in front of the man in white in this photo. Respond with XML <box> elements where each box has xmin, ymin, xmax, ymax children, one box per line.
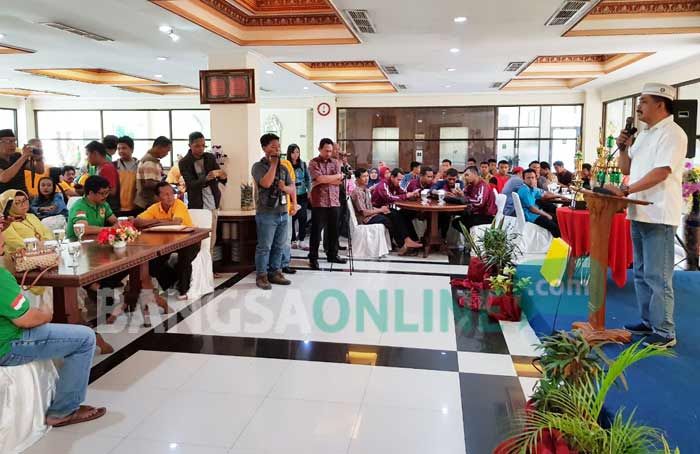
<box><xmin>572</xmin><ymin>190</ymin><xmax>651</xmax><ymax>343</ymax></box>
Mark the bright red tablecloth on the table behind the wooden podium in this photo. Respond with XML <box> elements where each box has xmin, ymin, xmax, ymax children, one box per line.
<box><xmin>557</xmin><ymin>207</ymin><xmax>632</xmax><ymax>287</ymax></box>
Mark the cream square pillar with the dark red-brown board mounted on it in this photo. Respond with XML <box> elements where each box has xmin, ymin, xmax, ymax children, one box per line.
<box><xmin>209</xmin><ymin>52</ymin><xmax>263</xmax><ymax>210</ymax></box>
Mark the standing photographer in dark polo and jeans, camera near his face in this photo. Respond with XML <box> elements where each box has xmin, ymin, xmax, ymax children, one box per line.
<box><xmin>251</xmin><ymin>133</ymin><xmax>296</xmax><ymax>290</ymax></box>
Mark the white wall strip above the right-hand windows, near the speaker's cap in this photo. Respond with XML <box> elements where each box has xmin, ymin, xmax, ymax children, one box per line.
<box><xmin>600</xmin><ymin>53</ymin><xmax>700</xmax><ymax>101</ymax></box>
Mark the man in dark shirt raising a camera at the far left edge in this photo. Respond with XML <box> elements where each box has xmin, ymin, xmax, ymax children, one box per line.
<box><xmin>0</xmin><ymin>129</ymin><xmax>44</xmax><ymax>193</ymax></box>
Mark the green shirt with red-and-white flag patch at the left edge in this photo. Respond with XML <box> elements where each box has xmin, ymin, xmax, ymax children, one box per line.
<box><xmin>0</xmin><ymin>268</ymin><xmax>29</xmax><ymax>358</ymax></box>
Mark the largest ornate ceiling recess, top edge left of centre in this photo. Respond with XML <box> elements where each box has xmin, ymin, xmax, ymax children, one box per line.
<box><xmin>149</xmin><ymin>0</ymin><xmax>360</xmax><ymax>46</ymax></box>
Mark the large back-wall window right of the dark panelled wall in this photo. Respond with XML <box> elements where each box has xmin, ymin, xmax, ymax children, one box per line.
<box><xmin>496</xmin><ymin>105</ymin><xmax>582</xmax><ymax>169</ymax></box>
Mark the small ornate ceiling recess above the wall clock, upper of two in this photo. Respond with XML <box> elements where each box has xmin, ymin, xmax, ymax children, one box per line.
<box><xmin>277</xmin><ymin>61</ymin><xmax>387</xmax><ymax>82</ymax></box>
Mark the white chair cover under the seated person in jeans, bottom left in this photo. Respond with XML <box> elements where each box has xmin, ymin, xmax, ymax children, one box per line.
<box><xmin>0</xmin><ymin>360</ymin><xmax>58</xmax><ymax>453</ymax></box>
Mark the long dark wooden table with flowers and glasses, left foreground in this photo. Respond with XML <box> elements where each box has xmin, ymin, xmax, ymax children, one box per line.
<box><xmin>5</xmin><ymin>229</ymin><xmax>209</xmax><ymax>323</ymax></box>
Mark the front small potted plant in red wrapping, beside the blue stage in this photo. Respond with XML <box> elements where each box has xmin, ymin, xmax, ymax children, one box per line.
<box><xmin>486</xmin><ymin>265</ymin><xmax>532</xmax><ymax>322</ymax></box>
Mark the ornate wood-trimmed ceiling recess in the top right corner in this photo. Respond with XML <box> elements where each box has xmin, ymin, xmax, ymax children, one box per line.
<box><xmin>564</xmin><ymin>0</ymin><xmax>700</xmax><ymax>36</ymax></box>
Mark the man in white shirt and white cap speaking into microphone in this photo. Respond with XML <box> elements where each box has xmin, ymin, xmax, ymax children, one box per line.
<box><xmin>615</xmin><ymin>83</ymin><xmax>688</xmax><ymax>347</ymax></box>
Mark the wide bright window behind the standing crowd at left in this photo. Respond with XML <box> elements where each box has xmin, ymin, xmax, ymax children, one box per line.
<box><xmin>35</xmin><ymin>110</ymin><xmax>211</xmax><ymax>167</ymax></box>
